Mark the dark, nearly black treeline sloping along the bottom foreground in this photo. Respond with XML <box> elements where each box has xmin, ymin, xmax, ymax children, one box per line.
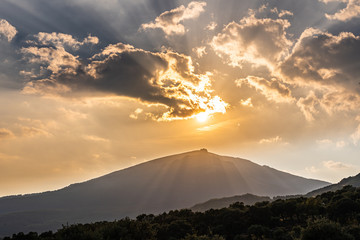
<box><xmin>4</xmin><ymin>186</ymin><xmax>360</xmax><ymax>240</ymax></box>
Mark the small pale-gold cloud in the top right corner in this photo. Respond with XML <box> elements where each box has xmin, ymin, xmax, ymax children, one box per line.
<box><xmin>322</xmin><ymin>0</ymin><xmax>360</xmax><ymax>22</ymax></box>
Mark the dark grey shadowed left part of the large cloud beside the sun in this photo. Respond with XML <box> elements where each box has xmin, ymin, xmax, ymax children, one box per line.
<box><xmin>74</xmin><ymin>44</ymin><xmax>170</xmax><ymax>104</ymax></box>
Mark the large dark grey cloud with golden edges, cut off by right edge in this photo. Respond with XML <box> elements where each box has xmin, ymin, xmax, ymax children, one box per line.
<box><xmin>280</xmin><ymin>29</ymin><xmax>360</xmax><ymax>93</ymax></box>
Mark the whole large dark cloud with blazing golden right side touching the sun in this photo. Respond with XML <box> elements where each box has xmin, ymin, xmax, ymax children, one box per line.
<box><xmin>87</xmin><ymin>44</ymin><xmax>225</xmax><ymax>119</ymax></box>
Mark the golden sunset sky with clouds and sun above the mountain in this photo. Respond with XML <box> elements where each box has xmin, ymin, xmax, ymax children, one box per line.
<box><xmin>0</xmin><ymin>0</ymin><xmax>360</xmax><ymax>196</ymax></box>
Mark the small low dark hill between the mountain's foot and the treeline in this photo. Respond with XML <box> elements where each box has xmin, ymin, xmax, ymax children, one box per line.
<box><xmin>190</xmin><ymin>193</ymin><xmax>271</xmax><ymax>212</ymax></box>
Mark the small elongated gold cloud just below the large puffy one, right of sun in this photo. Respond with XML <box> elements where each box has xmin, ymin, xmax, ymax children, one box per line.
<box><xmin>235</xmin><ymin>76</ymin><xmax>293</xmax><ymax>102</ymax></box>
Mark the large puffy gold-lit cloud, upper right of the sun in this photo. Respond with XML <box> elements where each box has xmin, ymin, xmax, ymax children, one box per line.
<box><xmin>210</xmin><ymin>13</ymin><xmax>292</xmax><ymax>69</ymax></box>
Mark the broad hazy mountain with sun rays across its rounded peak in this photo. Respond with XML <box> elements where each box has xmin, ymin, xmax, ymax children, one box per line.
<box><xmin>0</xmin><ymin>149</ymin><xmax>329</xmax><ymax>236</ymax></box>
